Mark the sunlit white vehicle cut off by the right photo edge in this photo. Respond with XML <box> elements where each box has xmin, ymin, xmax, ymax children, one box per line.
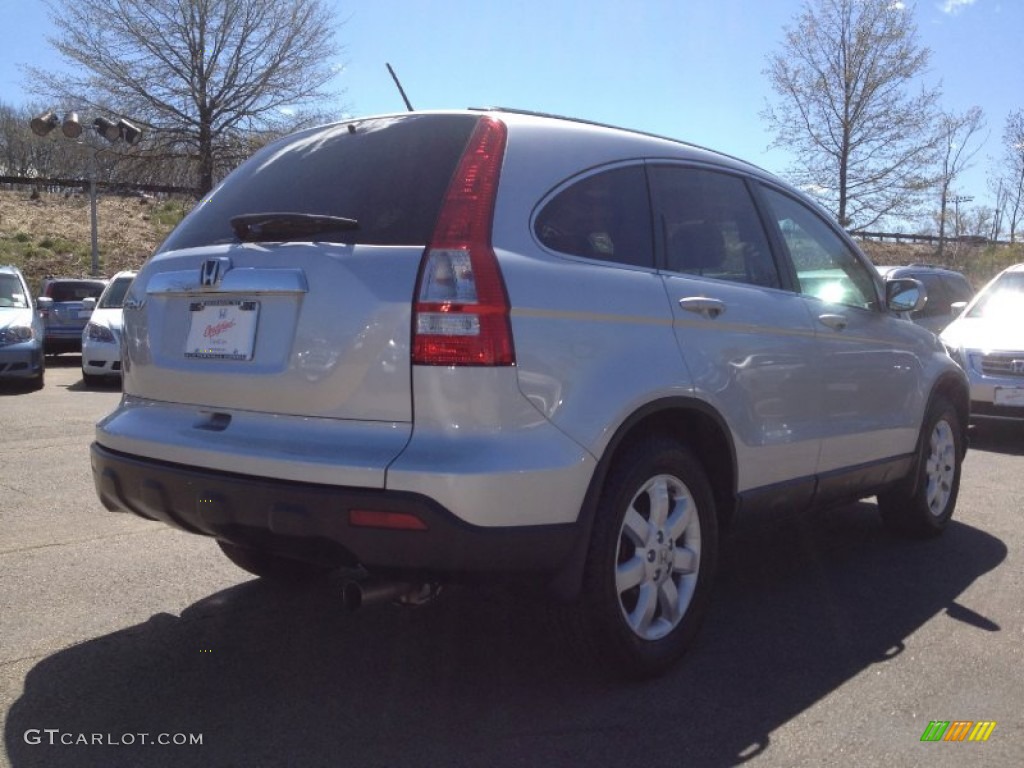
<box><xmin>941</xmin><ymin>264</ymin><xmax>1024</xmax><ymax>420</ymax></box>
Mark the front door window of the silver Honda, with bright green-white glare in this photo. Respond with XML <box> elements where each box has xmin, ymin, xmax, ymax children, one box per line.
<box><xmin>765</xmin><ymin>187</ymin><xmax>876</xmax><ymax>309</ymax></box>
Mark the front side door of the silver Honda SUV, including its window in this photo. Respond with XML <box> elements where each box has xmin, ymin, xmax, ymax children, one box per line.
<box><xmin>762</xmin><ymin>186</ymin><xmax>930</xmax><ymax>475</ymax></box>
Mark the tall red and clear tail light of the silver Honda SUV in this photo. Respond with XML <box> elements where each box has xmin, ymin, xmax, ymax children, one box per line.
<box><xmin>413</xmin><ymin>118</ymin><xmax>515</xmax><ymax>366</ymax></box>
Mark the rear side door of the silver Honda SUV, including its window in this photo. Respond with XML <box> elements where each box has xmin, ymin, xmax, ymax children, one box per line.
<box><xmin>648</xmin><ymin>163</ymin><xmax>821</xmax><ymax>505</ymax></box>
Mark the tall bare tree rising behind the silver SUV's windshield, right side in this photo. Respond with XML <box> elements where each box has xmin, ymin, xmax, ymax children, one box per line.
<box><xmin>762</xmin><ymin>0</ymin><xmax>938</xmax><ymax>228</ymax></box>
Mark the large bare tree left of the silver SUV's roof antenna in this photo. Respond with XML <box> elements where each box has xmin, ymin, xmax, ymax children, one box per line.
<box><xmin>28</xmin><ymin>0</ymin><xmax>339</xmax><ymax>194</ymax></box>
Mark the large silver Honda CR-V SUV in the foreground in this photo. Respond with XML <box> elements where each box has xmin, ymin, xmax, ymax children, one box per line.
<box><xmin>92</xmin><ymin>111</ymin><xmax>969</xmax><ymax>675</ymax></box>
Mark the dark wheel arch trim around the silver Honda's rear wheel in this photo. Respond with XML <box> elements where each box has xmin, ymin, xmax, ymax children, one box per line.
<box><xmin>550</xmin><ymin>397</ymin><xmax>736</xmax><ymax>601</ymax></box>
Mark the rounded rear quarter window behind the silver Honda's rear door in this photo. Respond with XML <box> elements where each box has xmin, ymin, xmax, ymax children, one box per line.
<box><xmin>534</xmin><ymin>165</ymin><xmax>654</xmax><ymax>267</ymax></box>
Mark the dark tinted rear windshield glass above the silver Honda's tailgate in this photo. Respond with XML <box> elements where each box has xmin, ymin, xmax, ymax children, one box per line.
<box><xmin>159</xmin><ymin>115</ymin><xmax>478</xmax><ymax>251</ymax></box>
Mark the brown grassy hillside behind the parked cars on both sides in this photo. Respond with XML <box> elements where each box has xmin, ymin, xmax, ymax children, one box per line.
<box><xmin>0</xmin><ymin>185</ymin><xmax>1024</xmax><ymax>290</ymax></box>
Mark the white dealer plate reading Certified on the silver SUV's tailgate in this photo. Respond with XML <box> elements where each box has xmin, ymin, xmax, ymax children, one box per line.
<box><xmin>185</xmin><ymin>300</ymin><xmax>259</xmax><ymax>360</ymax></box>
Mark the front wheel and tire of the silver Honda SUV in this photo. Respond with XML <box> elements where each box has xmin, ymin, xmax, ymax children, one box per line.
<box><xmin>879</xmin><ymin>396</ymin><xmax>964</xmax><ymax>539</ymax></box>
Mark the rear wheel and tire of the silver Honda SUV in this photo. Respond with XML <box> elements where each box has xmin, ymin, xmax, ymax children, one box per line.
<box><xmin>565</xmin><ymin>437</ymin><xmax>718</xmax><ymax>678</ymax></box>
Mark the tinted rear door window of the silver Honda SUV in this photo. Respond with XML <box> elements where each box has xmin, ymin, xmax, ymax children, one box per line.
<box><xmin>650</xmin><ymin>166</ymin><xmax>780</xmax><ymax>288</ymax></box>
